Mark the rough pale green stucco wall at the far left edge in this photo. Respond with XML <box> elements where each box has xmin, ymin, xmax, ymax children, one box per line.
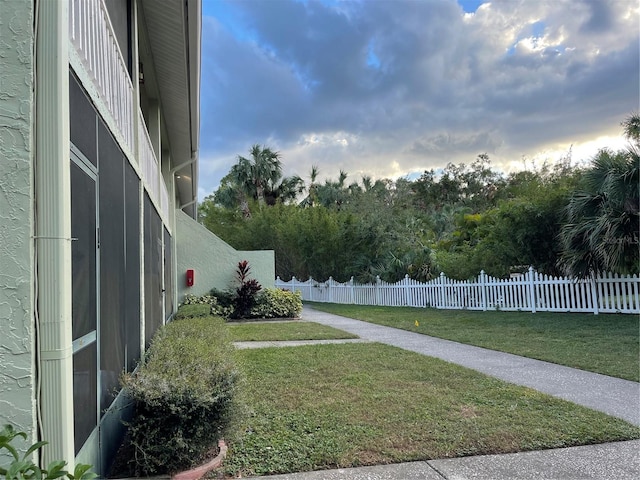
<box><xmin>0</xmin><ymin>0</ymin><xmax>35</xmax><ymax>438</ymax></box>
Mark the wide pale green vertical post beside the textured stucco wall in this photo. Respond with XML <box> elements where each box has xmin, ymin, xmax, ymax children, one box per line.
<box><xmin>35</xmin><ymin>0</ymin><xmax>75</xmax><ymax>471</ymax></box>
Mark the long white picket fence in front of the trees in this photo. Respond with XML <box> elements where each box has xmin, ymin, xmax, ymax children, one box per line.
<box><xmin>275</xmin><ymin>268</ymin><xmax>640</xmax><ymax>315</ymax></box>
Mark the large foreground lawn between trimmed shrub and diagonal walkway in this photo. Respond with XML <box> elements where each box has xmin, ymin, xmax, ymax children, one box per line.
<box><xmin>225</xmin><ymin>343</ymin><xmax>640</xmax><ymax>477</ymax></box>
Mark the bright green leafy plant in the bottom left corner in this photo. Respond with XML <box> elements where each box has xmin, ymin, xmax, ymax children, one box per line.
<box><xmin>0</xmin><ymin>424</ymin><xmax>97</xmax><ymax>480</ymax></box>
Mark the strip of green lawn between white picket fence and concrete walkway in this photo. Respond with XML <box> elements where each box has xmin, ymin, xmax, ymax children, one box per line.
<box><xmin>305</xmin><ymin>302</ymin><xmax>640</xmax><ymax>382</ymax></box>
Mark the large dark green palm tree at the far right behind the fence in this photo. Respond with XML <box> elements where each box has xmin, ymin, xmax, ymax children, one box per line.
<box><xmin>560</xmin><ymin>114</ymin><xmax>640</xmax><ymax>278</ymax></box>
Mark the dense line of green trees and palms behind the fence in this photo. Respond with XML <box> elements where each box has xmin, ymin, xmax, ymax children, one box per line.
<box><xmin>199</xmin><ymin>114</ymin><xmax>640</xmax><ymax>282</ymax></box>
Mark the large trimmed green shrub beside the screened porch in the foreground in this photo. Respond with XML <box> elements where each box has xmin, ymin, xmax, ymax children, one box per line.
<box><xmin>122</xmin><ymin>317</ymin><xmax>244</xmax><ymax>475</ymax></box>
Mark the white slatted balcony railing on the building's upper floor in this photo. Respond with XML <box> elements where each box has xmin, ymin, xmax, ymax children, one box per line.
<box><xmin>69</xmin><ymin>0</ymin><xmax>170</xmax><ymax>219</ymax></box>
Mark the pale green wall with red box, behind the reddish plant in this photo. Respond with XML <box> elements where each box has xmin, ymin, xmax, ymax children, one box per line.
<box><xmin>175</xmin><ymin>211</ymin><xmax>275</xmax><ymax>303</ymax></box>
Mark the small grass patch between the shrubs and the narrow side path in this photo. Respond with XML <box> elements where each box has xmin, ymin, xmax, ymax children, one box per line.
<box><xmin>227</xmin><ymin>321</ymin><xmax>358</xmax><ymax>342</ymax></box>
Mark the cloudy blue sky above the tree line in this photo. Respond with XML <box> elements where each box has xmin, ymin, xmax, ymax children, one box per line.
<box><xmin>198</xmin><ymin>0</ymin><xmax>640</xmax><ymax>199</ymax></box>
